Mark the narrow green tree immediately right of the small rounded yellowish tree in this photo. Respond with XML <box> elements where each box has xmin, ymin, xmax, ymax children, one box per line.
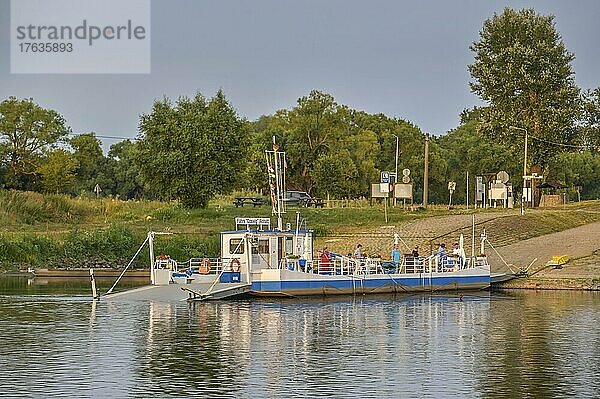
<box><xmin>69</xmin><ymin>133</ymin><xmax>106</xmax><ymax>192</ymax></box>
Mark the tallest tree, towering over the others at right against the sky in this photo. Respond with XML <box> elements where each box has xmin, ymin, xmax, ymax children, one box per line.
<box><xmin>469</xmin><ymin>8</ymin><xmax>579</xmax><ymax>170</ymax></box>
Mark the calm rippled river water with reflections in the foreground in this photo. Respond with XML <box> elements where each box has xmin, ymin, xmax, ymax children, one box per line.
<box><xmin>0</xmin><ymin>278</ymin><xmax>600</xmax><ymax>398</ymax></box>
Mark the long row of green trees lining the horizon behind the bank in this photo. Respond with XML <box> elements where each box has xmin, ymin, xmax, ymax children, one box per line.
<box><xmin>0</xmin><ymin>8</ymin><xmax>600</xmax><ymax>207</ymax></box>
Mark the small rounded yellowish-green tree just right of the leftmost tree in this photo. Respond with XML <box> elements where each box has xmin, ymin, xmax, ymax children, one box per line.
<box><xmin>37</xmin><ymin>149</ymin><xmax>78</xmax><ymax>194</ymax></box>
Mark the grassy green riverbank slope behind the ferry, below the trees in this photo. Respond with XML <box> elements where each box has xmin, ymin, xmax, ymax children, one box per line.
<box><xmin>0</xmin><ymin>190</ymin><xmax>600</xmax><ymax>270</ymax></box>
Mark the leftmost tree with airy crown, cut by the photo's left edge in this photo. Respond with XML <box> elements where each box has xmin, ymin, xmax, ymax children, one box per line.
<box><xmin>0</xmin><ymin>97</ymin><xmax>70</xmax><ymax>189</ymax></box>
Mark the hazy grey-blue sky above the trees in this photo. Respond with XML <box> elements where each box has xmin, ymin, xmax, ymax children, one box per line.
<box><xmin>0</xmin><ymin>0</ymin><xmax>600</xmax><ymax>149</ymax></box>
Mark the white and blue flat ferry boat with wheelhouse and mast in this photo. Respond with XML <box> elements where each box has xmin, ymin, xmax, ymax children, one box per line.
<box><xmin>103</xmin><ymin>142</ymin><xmax>490</xmax><ymax>300</ymax></box>
